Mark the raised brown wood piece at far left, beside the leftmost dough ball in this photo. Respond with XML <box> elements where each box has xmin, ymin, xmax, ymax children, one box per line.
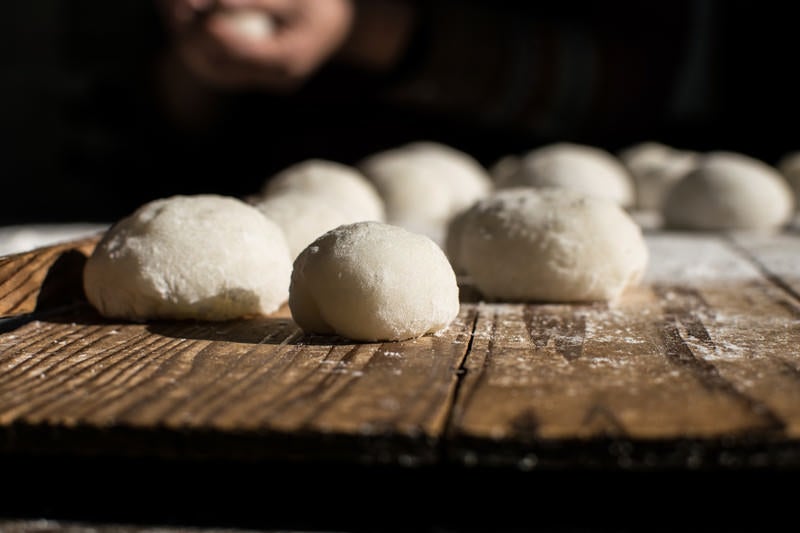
<box><xmin>0</xmin><ymin>234</ymin><xmax>101</xmax><ymax>318</ymax></box>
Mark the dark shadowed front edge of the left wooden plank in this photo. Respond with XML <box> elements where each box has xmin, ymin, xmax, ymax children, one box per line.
<box><xmin>0</xmin><ymin>422</ymin><xmax>440</xmax><ymax>467</ymax></box>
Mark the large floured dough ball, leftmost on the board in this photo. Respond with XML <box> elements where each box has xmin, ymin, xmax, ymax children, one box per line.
<box><xmin>83</xmin><ymin>195</ymin><xmax>292</xmax><ymax>321</ymax></box>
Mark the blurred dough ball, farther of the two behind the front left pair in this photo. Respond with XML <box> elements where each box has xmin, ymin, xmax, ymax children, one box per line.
<box><xmin>262</xmin><ymin>159</ymin><xmax>385</xmax><ymax>222</ymax></box>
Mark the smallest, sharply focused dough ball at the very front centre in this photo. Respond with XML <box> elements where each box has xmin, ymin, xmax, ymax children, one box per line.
<box><xmin>289</xmin><ymin>222</ymin><xmax>459</xmax><ymax>341</ymax></box>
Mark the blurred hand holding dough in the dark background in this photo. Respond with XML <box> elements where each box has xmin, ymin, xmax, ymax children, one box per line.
<box><xmin>160</xmin><ymin>0</ymin><xmax>354</xmax><ymax>90</ymax></box>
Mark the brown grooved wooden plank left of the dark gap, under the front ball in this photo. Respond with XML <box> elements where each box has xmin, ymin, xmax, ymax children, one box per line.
<box><xmin>0</xmin><ymin>300</ymin><xmax>474</xmax><ymax>463</ymax></box>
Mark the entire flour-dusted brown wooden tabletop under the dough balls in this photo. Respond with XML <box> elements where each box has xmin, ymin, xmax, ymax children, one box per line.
<box><xmin>0</xmin><ymin>231</ymin><xmax>800</xmax><ymax>469</ymax></box>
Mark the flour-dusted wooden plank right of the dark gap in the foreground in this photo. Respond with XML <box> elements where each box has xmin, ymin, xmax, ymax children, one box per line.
<box><xmin>449</xmin><ymin>234</ymin><xmax>800</xmax><ymax>466</ymax></box>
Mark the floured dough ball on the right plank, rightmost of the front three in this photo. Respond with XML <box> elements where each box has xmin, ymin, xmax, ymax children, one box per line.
<box><xmin>461</xmin><ymin>187</ymin><xmax>648</xmax><ymax>302</ymax></box>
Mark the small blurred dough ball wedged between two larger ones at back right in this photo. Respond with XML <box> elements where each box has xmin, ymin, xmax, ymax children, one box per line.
<box><xmin>619</xmin><ymin>141</ymin><xmax>700</xmax><ymax>210</ymax></box>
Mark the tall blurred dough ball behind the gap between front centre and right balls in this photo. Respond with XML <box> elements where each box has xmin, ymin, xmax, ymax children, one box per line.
<box><xmin>359</xmin><ymin>141</ymin><xmax>493</xmax><ymax>245</ymax></box>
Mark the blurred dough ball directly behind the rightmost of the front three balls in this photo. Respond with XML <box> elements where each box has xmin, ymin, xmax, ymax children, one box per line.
<box><xmin>497</xmin><ymin>142</ymin><xmax>635</xmax><ymax>207</ymax></box>
